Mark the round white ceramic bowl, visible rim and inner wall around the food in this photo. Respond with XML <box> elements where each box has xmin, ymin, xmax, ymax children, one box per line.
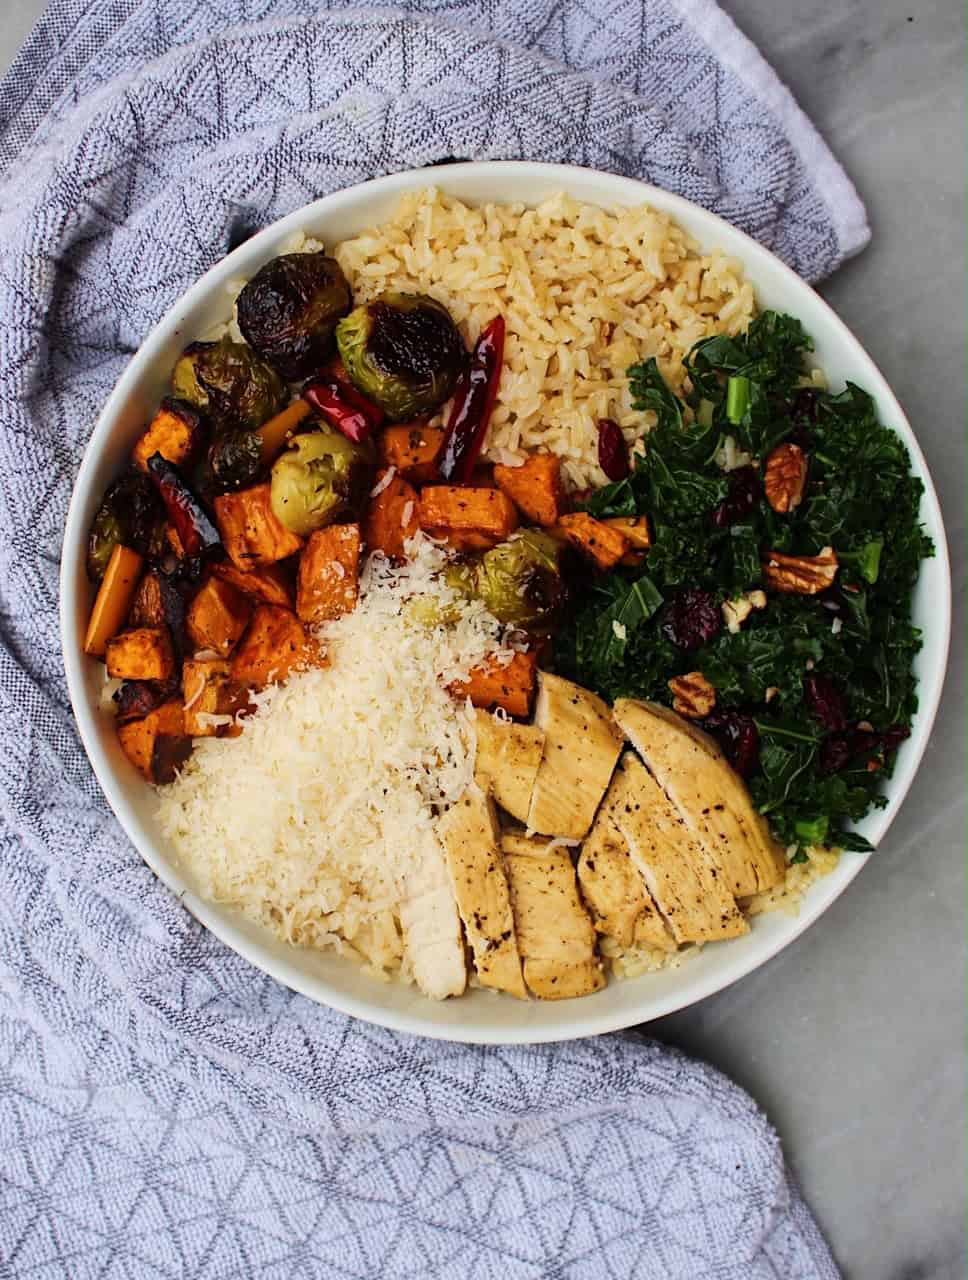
<box><xmin>60</xmin><ymin>161</ymin><xmax>951</xmax><ymax>1043</ymax></box>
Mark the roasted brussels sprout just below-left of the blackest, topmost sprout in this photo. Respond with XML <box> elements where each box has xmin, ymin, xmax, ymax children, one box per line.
<box><xmin>172</xmin><ymin>338</ymin><xmax>288</xmax><ymax>431</ymax></box>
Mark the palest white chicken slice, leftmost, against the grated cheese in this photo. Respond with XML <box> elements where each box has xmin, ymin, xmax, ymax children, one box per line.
<box><xmin>399</xmin><ymin>832</ymin><xmax>467</xmax><ymax>1000</ymax></box>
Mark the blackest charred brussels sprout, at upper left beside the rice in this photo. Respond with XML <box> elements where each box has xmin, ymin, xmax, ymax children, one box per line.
<box><xmin>237</xmin><ymin>253</ymin><xmax>353</xmax><ymax>383</ymax></box>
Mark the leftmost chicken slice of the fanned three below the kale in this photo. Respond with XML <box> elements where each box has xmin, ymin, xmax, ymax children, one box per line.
<box><xmin>577</xmin><ymin>805</ymin><xmax>676</xmax><ymax>951</ymax></box>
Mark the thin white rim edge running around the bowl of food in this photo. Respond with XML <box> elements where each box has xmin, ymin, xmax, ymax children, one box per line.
<box><xmin>59</xmin><ymin>160</ymin><xmax>951</xmax><ymax>1044</ymax></box>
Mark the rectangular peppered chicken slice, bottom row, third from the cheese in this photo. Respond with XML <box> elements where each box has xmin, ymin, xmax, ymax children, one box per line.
<box><xmin>504</xmin><ymin>841</ymin><xmax>606</xmax><ymax>1000</ymax></box>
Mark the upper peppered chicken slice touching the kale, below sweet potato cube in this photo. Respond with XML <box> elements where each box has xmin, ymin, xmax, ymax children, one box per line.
<box><xmin>528</xmin><ymin>671</ymin><xmax>622</xmax><ymax>840</ymax></box>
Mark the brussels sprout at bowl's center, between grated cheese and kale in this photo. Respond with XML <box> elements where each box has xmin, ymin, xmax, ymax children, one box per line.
<box><xmin>463</xmin><ymin>529</ymin><xmax>565</xmax><ymax>628</ymax></box>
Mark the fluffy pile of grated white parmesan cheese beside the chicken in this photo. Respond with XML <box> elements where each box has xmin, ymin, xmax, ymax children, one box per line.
<box><xmin>159</xmin><ymin>534</ymin><xmax>513</xmax><ymax>977</ymax></box>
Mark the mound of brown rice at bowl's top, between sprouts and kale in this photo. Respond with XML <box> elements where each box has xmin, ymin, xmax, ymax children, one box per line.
<box><xmin>330</xmin><ymin>188</ymin><xmax>754</xmax><ymax>488</ymax></box>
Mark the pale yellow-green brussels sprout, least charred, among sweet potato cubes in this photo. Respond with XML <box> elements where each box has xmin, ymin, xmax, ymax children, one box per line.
<box><xmin>270</xmin><ymin>428</ymin><xmax>367</xmax><ymax>538</ymax></box>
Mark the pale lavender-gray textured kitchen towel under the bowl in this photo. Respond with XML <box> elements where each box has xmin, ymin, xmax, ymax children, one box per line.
<box><xmin>0</xmin><ymin>0</ymin><xmax>867</xmax><ymax>1280</ymax></box>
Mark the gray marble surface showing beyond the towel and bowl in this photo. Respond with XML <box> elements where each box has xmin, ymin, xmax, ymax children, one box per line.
<box><xmin>0</xmin><ymin>0</ymin><xmax>967</xmax><ymax>1280</ymax></box>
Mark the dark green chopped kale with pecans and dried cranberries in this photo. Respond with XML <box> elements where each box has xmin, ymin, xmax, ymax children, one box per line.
<box><xmin>556</xmin><ymin>311</ymin><xmax>932</xmax><ymax>850</ymax></box>
